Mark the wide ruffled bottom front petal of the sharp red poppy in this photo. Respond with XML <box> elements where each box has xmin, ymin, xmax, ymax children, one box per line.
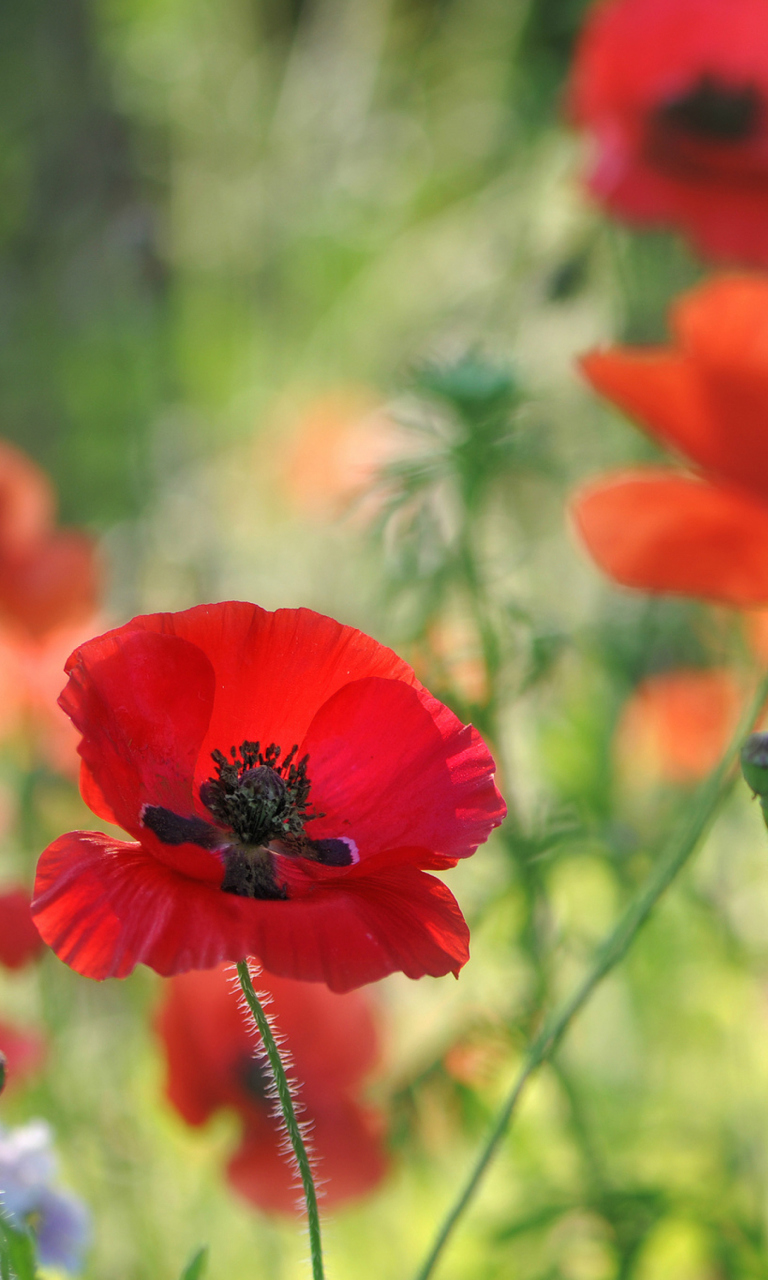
<box><xmin>33</xmin><ymin>832</ymin><xmax>468</xmax><ymax>991</ymax></box>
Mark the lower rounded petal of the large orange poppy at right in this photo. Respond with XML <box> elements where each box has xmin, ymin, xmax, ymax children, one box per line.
<box><xmin>573</xmin><ymin>468</ymin><xmax>768</xmax><ymax>607</ymax></box>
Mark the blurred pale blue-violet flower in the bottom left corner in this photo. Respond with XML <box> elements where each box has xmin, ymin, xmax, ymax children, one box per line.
<box><xmin>0</xmin><ymin>1120</ymin><xmax>90</xmax><ymax>1271</ymax></box>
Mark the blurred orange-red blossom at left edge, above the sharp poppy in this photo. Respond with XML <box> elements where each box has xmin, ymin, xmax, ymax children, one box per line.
<box><xmin>0</xmin><ymin>440</ymin><xmax>99</xmax><ymax>639</ymax></box>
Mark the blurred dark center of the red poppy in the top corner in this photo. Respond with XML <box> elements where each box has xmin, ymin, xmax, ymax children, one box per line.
<box><xmin>658</xmin><ymin>73</ymin><xmax>763</xmax><ymax>142</ymax></box>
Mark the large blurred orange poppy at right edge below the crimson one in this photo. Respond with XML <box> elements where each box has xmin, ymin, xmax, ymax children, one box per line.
<box><xmin>573</xmin><ymin>275</ymin><xmax>768</xmax><ymax>607</ymax></box>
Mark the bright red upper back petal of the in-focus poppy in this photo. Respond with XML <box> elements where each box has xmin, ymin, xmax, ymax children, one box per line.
<box><xmin>114</xmin><ymin>600</ymin><xmax>417</xmax><ymax>783</ymax></box>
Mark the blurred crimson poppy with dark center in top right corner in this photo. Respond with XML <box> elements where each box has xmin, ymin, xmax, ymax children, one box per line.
<box><xmin>568</xmin><ymin>0</ymin><xmax>768</xmax><ymax>266</ymax></box>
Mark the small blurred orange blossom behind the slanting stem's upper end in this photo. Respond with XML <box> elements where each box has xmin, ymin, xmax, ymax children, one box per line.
<box><xmin>614</xmin><ymin>668</ymin><xmax>744</xmax><ymax>787</ymax></box>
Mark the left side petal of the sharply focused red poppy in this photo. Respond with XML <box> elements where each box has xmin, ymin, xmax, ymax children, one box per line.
<box><xmin>60</xmin><ymin>630</ymin><xmax>221</xmax><ymax>881</ymax></box>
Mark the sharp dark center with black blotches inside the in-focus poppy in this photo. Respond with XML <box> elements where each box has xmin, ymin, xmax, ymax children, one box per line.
<box><xmin>141</xmin><ymin>741</ymin><xmax>357</xmax><ymax>900</ymax></box>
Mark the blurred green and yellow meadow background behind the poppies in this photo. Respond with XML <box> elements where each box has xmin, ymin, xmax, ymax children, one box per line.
<box><xmin>0</xmin><ymin>0</ymin><xmax>768</xmax><ymax>1280</ymax></box>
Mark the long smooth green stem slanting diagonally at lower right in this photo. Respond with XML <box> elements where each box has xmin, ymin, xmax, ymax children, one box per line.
<box><xmin>416</xmin><ymin>676</ymin><xmax>768</xmax><ymax>1280</ymax></box>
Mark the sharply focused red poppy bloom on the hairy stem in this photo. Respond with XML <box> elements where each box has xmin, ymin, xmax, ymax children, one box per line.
<box><xmin>33</xmin><ymin>602</ymin><xmax>504</xmax><ymax>991</ymax></box>
